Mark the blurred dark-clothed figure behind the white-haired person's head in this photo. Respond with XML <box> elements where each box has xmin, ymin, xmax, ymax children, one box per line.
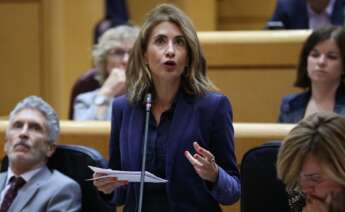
<box><xmin>93</xmin><ymin>0</ymin><xmax>129</xmax><ymax>44</ymax></box>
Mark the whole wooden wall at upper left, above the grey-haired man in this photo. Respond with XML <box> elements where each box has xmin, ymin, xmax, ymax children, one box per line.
<box><xmin>0</xmin><ymin>0</ymin><xmax>103</xmax><ymax>118</ymax></box>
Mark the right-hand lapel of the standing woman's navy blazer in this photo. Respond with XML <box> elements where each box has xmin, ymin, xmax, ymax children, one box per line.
<box><xmin>166</xmin><ymin>92</ymin><xmax>193</xmax><ymax>179</ymax></box>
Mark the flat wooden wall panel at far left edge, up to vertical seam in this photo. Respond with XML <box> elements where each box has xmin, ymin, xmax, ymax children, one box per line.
<box><xmin>0</xmin><ymin>0</ymin><xmax>42</xmax><ymax>116</ymax></box>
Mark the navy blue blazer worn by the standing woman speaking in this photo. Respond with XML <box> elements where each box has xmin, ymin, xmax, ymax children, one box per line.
<box><xmin>109</xmin><ymin>92</ymin><xmax>240</xmax><ymax>212</ymax></box>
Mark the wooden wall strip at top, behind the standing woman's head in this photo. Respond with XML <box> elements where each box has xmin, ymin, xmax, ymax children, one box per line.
<box><xmin>127</xmin><ymin>0</ymin><xmax>276</xmax><ymax>30</ymax></box>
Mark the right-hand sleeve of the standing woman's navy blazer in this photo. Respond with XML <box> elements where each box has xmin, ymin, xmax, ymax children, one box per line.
<box><xmin>210</xmin><ymin>95</ymin><xmax>241</xmax><ymax>204</ymax></box>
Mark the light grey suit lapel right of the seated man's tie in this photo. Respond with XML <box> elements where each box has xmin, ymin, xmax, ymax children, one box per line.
<box><xmin>9</xmin><ymin>167</ymin><xmax>51</xmax><ymax>211</ymax></box>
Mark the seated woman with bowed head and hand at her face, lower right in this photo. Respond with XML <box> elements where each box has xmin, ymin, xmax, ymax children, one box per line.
<box><xmin>277</xmin><ymin>112</ymin><xmax>345</xmax><ymax>212</ymax></box>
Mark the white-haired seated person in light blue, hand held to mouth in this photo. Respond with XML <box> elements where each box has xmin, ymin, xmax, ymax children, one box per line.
<box><xmin>73</xmin><ymin>25</ymin><xmax>139</xmax><ymax>120</ymax></box>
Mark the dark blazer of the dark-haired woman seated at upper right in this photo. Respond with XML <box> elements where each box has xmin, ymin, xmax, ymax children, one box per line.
<box><xmin>278</xmin><ymin>88</ymin><xmax>345</xmax><ymax>123</ymax></box>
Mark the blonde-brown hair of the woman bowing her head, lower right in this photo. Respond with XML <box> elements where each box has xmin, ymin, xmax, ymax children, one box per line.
<box><xmin>277</xmin><ymin>112</ymin><xmax>345</xmax><ymax>190</ymax></box>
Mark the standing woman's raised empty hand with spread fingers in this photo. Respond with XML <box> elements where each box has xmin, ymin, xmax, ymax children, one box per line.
<box><xmin>184</xmin><ymin>142</ymin><xmax>218</xmax><ymax>183</ymax></box>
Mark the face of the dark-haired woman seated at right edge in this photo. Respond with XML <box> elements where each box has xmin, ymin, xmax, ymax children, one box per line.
<box><xmin>307</xmin><ymin>39</ymin><xmax>343</xmax><ymax>84</ymax></box>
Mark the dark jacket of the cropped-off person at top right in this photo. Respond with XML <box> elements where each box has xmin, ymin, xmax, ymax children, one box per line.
<box><xmin>270</xmin><ymin>0</ymin><xmax>344</xmax><ymax>29</ymax></box>
